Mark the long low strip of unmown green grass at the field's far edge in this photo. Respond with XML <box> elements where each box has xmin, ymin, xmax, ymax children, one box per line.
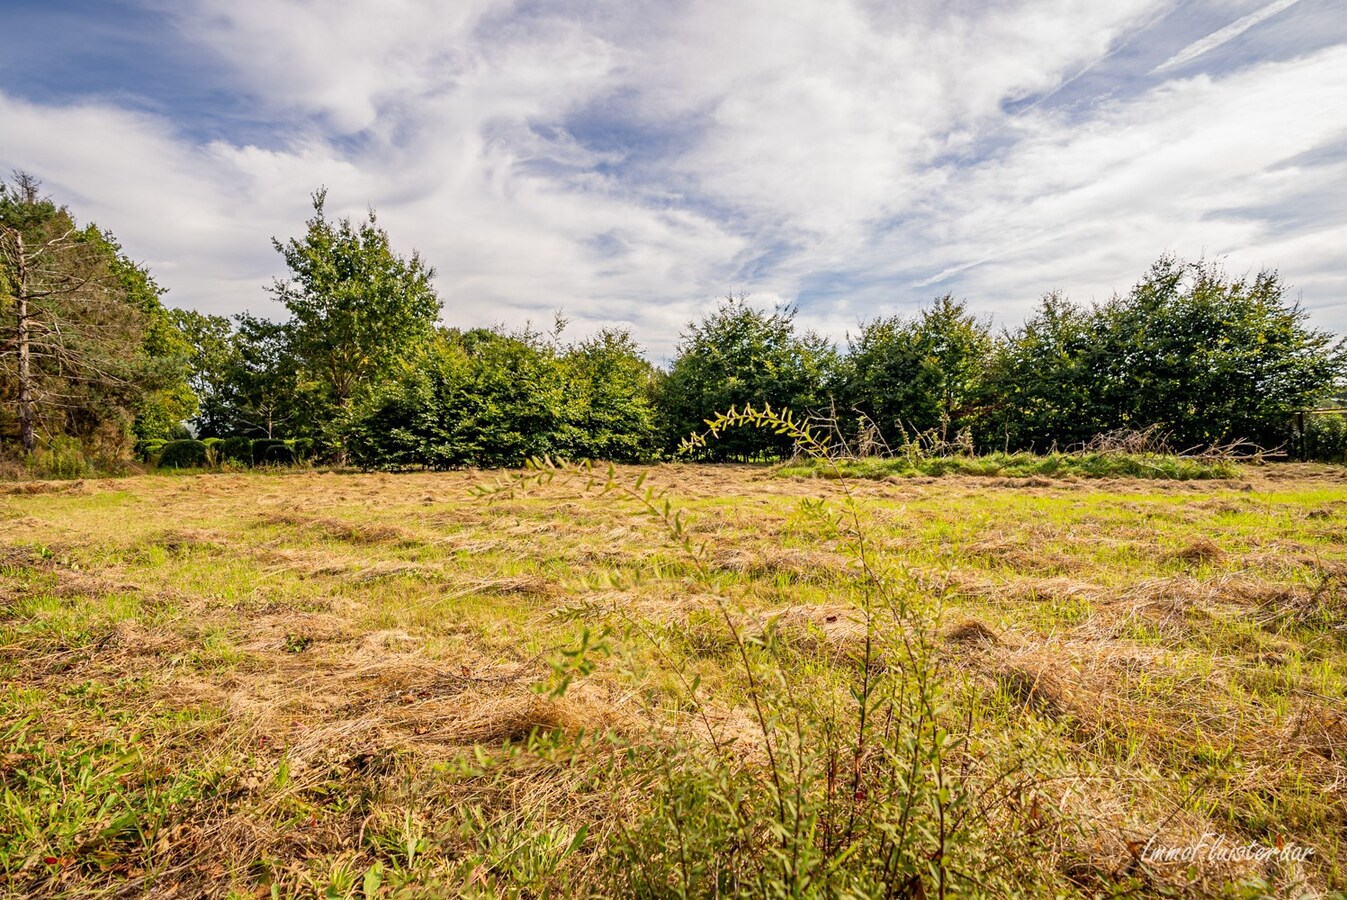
<box><xmin>781</xmin><ymin>453</ymin><xmax>1241</xmax><ymax>481</ymax></box>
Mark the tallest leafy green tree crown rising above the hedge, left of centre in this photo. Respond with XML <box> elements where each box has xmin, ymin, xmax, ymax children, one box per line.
<box><xmin>272</xmin><ymin>190</ymin><xmax>440</xmax><ymax>411</ymax></box>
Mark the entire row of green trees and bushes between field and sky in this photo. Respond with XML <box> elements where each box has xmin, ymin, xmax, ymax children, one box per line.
<box><xmin>0</xmin><ymin>174</ymin><xmax>1347</xmax><ymax>469</ymax></box>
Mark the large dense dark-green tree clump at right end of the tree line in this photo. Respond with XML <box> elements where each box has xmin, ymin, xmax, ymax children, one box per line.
<box><xmin>990</xmin><ymin>256</ymin><xmax>1347</xmax><ymax>449</ymax></box>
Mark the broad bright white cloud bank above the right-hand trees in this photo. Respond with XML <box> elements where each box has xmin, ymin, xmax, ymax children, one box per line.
<box><xmin>883</xmin><ymin>47</ymin><xmax>1347</xmax><ymax>327</ymax></box>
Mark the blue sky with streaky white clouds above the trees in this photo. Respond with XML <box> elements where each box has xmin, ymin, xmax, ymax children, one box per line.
<box><xmin>0</xmin><ymin>0</ymin><xmax>1347</xmax><ymax>361</ymax></box>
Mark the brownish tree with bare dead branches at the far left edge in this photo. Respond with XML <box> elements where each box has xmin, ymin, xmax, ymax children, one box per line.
<box><xmin>0</xmin><ymin>172</ymin><xmax>194</xmax><ymax>454</ymax></box>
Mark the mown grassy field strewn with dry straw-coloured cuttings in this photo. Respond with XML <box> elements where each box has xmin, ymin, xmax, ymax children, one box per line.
<box><xmin>0</xmin><ymin>465</ymin><xmax>1347</xmax><ymax>897</ymax></box>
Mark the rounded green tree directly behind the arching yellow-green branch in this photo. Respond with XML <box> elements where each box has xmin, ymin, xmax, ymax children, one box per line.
<box><xmin>659</xmin><ymin>296</ymin><xmax>838</xmax><ymax>461</ymax></box>
